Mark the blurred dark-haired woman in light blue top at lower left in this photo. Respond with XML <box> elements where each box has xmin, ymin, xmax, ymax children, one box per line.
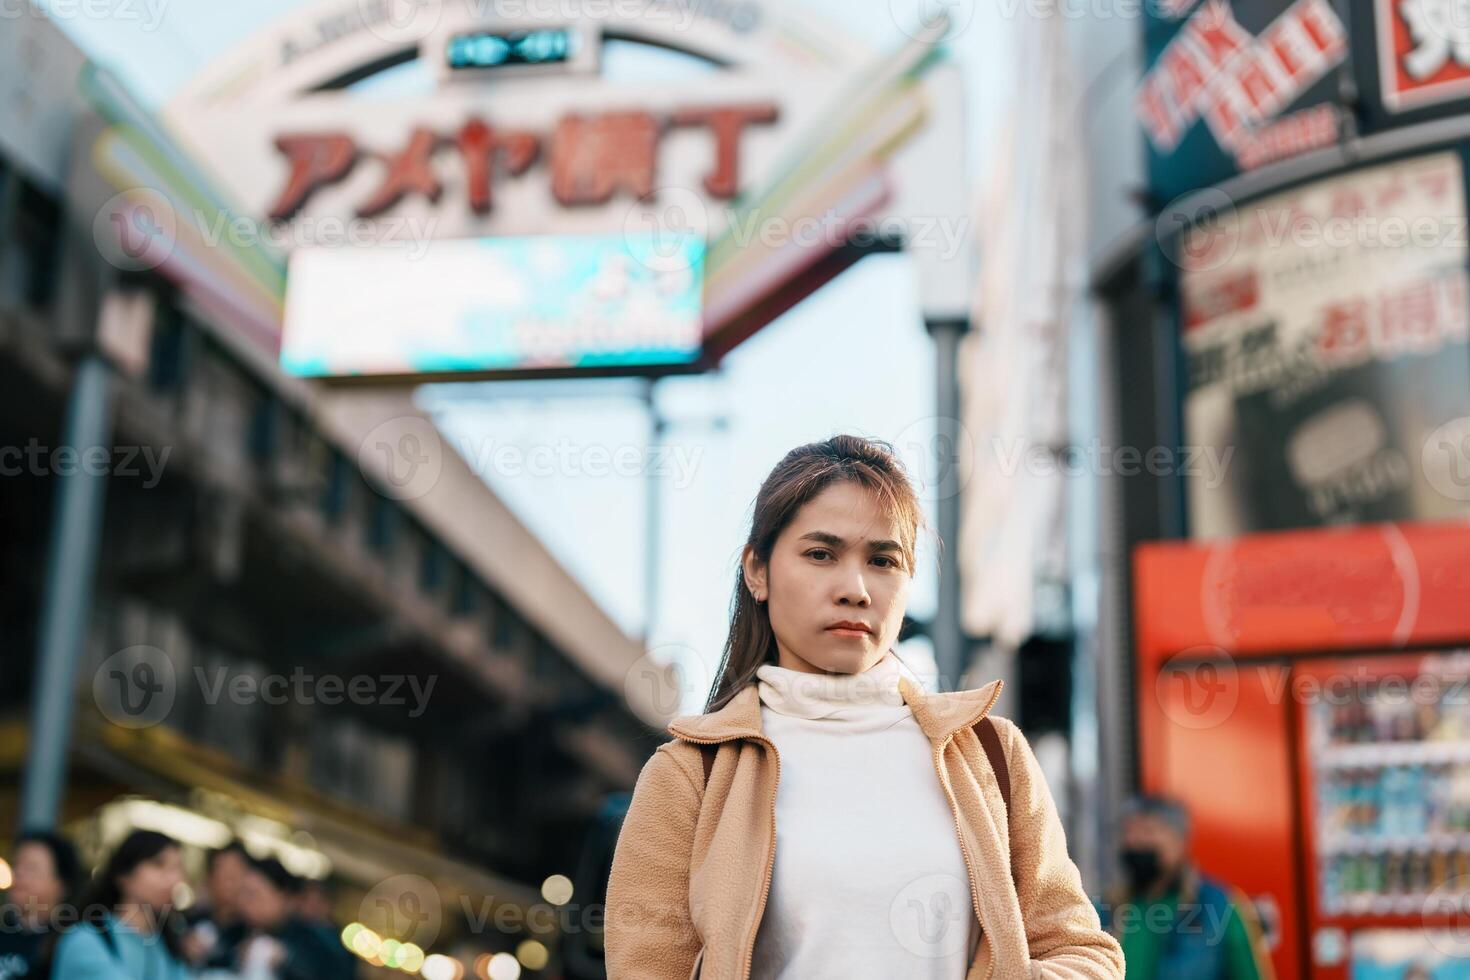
<box><xmin>51</xmin><ymin>830</ymin><xmax>190</xmax><ymax>980</ymax></box>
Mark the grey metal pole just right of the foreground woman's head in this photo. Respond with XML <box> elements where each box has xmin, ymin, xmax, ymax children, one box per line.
<box><xmin>926</xmin><ymin>319</ymin><xmax>970</xmax><ymax>691</ymax></box>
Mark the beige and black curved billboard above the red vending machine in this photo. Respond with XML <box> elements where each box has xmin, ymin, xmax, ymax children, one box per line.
<box><xmin>1177</xmin><ymin>151</ymin><xmax>1470</xmax><ymax>538</ymax></box>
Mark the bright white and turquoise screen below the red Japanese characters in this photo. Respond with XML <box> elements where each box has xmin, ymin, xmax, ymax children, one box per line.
<box><xmin>281</xmin><ymin>235</ymin><xmax>704</xmax><ymax>381</ymax></box>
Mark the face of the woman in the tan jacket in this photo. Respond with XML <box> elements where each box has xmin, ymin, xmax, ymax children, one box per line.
<box><xmin>744</xmin><ymin>480</ymin><xmax>911</xmax><ymax>673</ymax></box>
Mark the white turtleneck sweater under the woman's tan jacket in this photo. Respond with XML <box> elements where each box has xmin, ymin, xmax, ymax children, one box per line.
<box><xmin>751</xmin><ymin>651</ymin><xmax>979</xmax><ymax>980</ymax></box>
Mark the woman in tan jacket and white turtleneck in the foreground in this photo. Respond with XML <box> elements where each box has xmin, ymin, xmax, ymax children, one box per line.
<box><xmin>606</xmin><ymin>436</ymin><xmax>1123</xmax><ymax>980</ymax></box>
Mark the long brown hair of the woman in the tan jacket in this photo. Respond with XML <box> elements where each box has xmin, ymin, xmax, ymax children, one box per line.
<box><xmin>704</xmin><ymin>435</ymin><xmax>925</xmax><ymax>713</ymax></box>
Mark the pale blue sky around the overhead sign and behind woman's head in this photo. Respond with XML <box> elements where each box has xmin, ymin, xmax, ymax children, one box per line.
<box><xmin>38</xmin><ymin>0</ymin><xmax>1010</xmax><ymax>710</ymax></box>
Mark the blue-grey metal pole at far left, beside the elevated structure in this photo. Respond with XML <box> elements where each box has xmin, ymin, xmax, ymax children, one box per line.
<box><xmin>21</xmin><ymin>353</ymin><xmax>112</xmax><ymax>829</ymax></box>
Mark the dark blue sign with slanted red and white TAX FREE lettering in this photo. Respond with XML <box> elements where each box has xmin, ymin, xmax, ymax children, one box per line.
<box><xmin>1135</xmin><ymin>0</ymin><xmax>1348</xmax><ymax>204</ymax></box>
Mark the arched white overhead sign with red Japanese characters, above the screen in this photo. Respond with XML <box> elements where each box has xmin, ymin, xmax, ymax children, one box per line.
<box><xmin>165</xmin><ymin>0</ymin><xmax>873</xmax><ymax>250</ymax></box>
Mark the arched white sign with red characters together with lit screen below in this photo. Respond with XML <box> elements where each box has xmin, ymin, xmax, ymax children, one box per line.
<box><xmin>152</xmin><ymin>0</ymin><xmax>893</xmax><ymax>383</ymax></box>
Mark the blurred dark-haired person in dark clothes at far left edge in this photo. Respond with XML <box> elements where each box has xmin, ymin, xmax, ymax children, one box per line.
<box><xmin>0</xmin><ymin>830</ymin><xmax>81</xmax><ymax>980</ymax></box>
